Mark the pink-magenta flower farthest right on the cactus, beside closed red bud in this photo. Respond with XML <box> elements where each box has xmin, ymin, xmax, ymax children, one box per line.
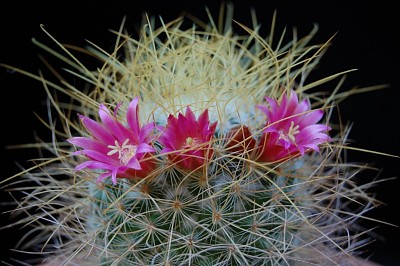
<box><xmin>257</xmin><ymin>90</ymin><xmax>331</xmax><ymax>162</ymax></box>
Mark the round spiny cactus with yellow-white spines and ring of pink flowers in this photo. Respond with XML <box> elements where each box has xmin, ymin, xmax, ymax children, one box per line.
<box><xmin>1</xmin><ymin>5</ymin><xmax>392</xmax><ymax>265</ymax></box>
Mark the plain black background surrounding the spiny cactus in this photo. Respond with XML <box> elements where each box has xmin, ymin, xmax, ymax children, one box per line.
<box><xmin>0</xmin><ymin>0</ymin><xmax>400</xmax><ymax>265</ymax></box>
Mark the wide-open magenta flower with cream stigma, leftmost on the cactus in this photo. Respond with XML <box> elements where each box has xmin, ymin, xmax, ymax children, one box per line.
<box><xmin>68</xmin><ymin>97</ymin><xmax>155</xmax><ymax>184</ymax></box>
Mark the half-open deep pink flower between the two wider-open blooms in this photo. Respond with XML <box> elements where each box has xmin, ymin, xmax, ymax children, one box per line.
<box><xmin>159</xmin><ymin>106</ymin><xmax>217</xmax><ymax>171</ymax></box>
